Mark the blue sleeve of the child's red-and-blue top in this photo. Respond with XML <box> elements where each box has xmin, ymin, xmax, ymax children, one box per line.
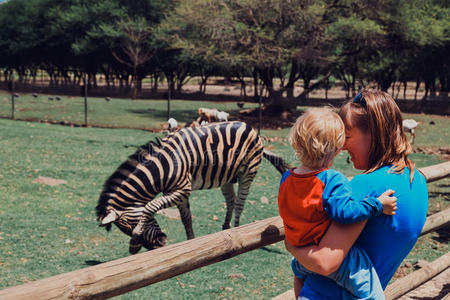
<box><xmin>323</xmin><ymin>171</ymin><xmax>383</xmax><ymax>224</ymax></box>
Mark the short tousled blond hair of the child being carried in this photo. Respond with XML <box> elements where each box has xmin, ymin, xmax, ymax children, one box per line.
<box><xmin>289</xmin><ymin>107</ymin><xmax>345</xmax><ymax>168</ymax></box>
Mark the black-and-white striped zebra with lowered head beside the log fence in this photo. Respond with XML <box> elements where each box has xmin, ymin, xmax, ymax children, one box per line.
<box><xmin>96</xmin><ymin>121</ymin><xmax>289</xmax><ymax>254</ymax></box>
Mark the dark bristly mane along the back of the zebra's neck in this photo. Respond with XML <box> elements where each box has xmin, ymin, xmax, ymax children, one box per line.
<box><xmin>95</xmin><ymin>135</ymin><xmax>171</xmax><ymax>231</ymax></box>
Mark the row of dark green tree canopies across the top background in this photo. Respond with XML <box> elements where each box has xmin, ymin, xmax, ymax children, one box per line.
<box><xmin>0</xmin><ymin>0</ymin><xmax>450</xmax><ymax>105</ymax></box>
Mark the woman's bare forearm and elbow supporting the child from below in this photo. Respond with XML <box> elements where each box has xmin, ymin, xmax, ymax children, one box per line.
<box><xmin>285</xmin><ymin>220</ymin><xmax>367</xmax><ymax>276</ymax></box>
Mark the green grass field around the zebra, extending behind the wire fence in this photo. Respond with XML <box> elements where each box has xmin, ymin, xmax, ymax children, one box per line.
<box><xmin>0</xmin><ymin>98</ymin><xmax>450</xmax><ymax>299</ymax></box>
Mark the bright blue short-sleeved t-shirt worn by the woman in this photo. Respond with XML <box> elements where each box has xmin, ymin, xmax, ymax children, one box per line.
<box><xmin>300</xmin><ymin>166</ymin><xmax>428</xmax><ymax>299</ymax></box>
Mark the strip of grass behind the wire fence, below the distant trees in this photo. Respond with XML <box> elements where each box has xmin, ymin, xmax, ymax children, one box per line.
<box><xmin>0</xmin><ymin>93</ymin><xmax>256</xmax><ymax>129</ymax></box>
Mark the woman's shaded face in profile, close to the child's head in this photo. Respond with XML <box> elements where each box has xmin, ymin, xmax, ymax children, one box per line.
<box><xmin>343</xmin><ymin>127</ymin><xmax>372</xmax><ymax>170</ymax></box>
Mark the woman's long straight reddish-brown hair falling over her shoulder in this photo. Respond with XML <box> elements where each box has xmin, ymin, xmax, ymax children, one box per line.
<box><xmin>339</xmin><ymin>90</ymin><xmax>414</xmax><ymax>182</ymax></box>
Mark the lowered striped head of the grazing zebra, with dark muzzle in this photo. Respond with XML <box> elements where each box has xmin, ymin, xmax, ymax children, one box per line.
<box><xmin>99</xmin><ymin>209</ymin><xmax>167</xmax><ymax>254</ymax></box>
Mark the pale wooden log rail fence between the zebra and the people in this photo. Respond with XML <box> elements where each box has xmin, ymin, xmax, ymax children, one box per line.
<box><xmin>0</xmin><ymin>162</ymin><xmax>450</xmax><ymax>300</ymax></box>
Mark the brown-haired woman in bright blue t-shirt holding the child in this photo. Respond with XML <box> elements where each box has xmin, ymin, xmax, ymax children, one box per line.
<box><xmin>285</xmin><ymin>91</ymin><xmax>428</xmax><ymax>299</ymax></box>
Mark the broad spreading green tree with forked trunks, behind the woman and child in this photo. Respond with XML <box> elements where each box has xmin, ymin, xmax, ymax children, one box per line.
<box><xmin>160</xmin><ymin>0</ymin><xmax>394</xmax><ymax>108</ymax></box>
